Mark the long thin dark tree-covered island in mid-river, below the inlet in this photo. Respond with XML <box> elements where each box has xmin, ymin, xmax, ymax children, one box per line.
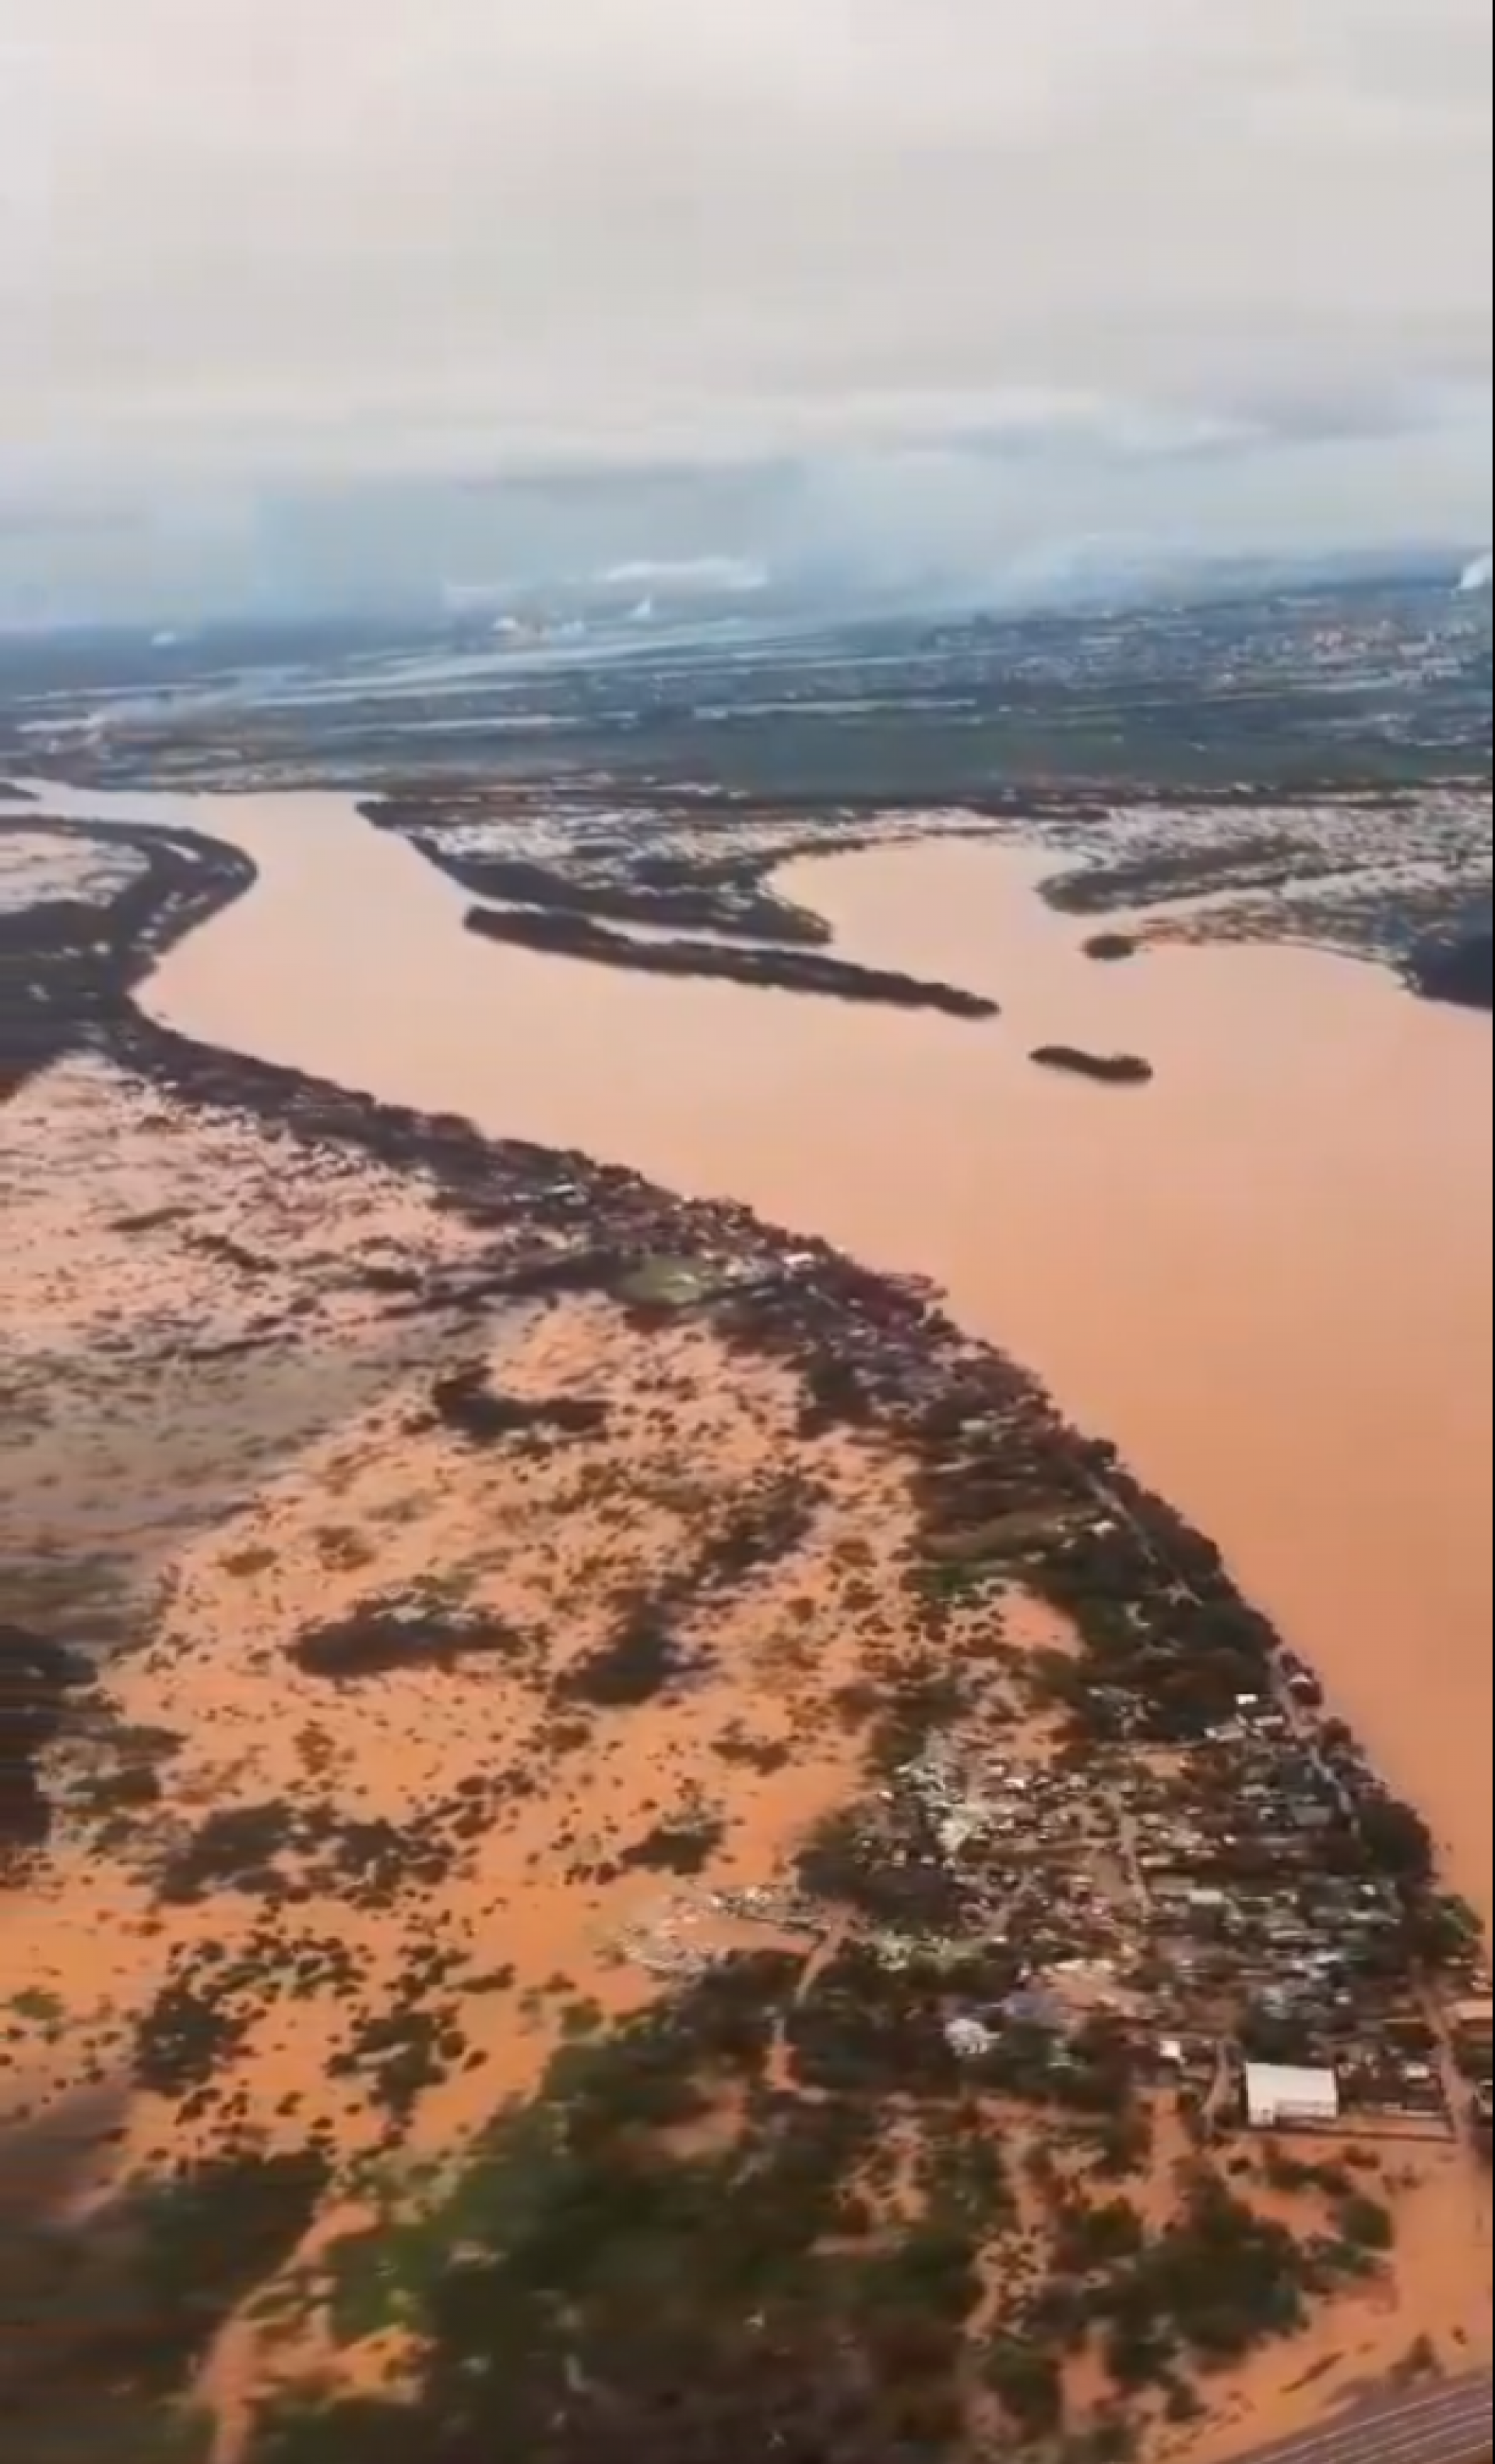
<box><xmin>463</xmin><ymin>906</ymin><xmax>997</xmax><ymax>1018</ymax></box>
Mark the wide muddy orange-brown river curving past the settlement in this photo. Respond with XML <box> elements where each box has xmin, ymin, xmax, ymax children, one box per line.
<box><xmin>12</xmin><ymin>788</ymin><xmax>1490</xmax><ymax>1912</ymax></box>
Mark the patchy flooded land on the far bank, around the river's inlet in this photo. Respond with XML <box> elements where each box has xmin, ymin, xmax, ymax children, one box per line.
<box><xmin>360</xmin><ymin>771</ymin><xmax>1490</xmax><ymax>1025</ymax></box>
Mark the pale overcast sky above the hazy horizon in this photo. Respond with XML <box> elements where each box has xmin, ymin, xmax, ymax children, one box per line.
<box><xmin>0</xmin><ymin>0</ymin><xmax>1490</xmax><ymax>611</ymax></box>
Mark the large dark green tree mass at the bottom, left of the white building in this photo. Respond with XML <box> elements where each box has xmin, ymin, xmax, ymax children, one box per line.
<box><xmin>254</xmin><ymin>1954</ymin><xmax>980</xmax><ymax>2464</ymax></box>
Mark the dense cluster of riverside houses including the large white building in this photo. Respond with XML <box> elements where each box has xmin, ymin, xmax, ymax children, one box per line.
<box><xmin>862</xmin><ymin>1698</ymin><xmax>1490</xmax><ymax>2136</ymax></box>
